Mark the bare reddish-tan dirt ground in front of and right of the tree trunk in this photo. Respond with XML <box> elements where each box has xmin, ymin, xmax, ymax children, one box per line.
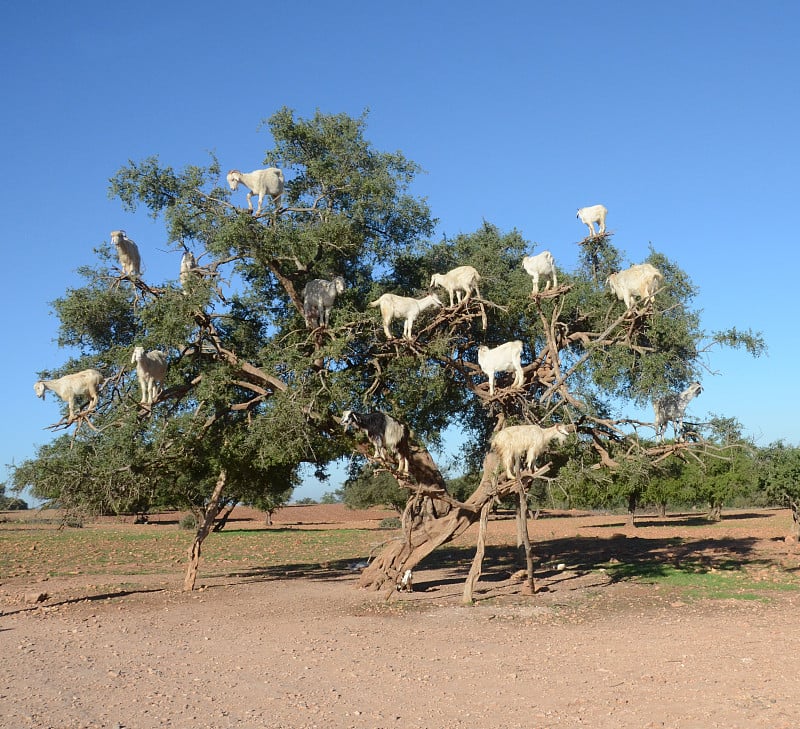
<box><xmin>0</xmin><ymin>507</ymin><xmax>800</xmax><ymax>729</ymax></box>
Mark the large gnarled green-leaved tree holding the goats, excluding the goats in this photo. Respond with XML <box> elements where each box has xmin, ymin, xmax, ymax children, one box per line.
<box><xmin>14</xmin><ymin>109</ymin><xmax>763</xmax><ymax>589</ymax></box>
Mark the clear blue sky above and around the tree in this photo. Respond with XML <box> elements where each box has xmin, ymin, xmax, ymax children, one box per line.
<box><xmin>0</xmin><ymin>0</ymin><xmax>800</xmax><ymax>496</ymax></box>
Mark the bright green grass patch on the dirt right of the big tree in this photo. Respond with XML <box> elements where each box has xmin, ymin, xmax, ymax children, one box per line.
<box><xmin>604</xmin><ymin>562</ymin><xmax>800</xmax><ymax>602</ymax></box>
